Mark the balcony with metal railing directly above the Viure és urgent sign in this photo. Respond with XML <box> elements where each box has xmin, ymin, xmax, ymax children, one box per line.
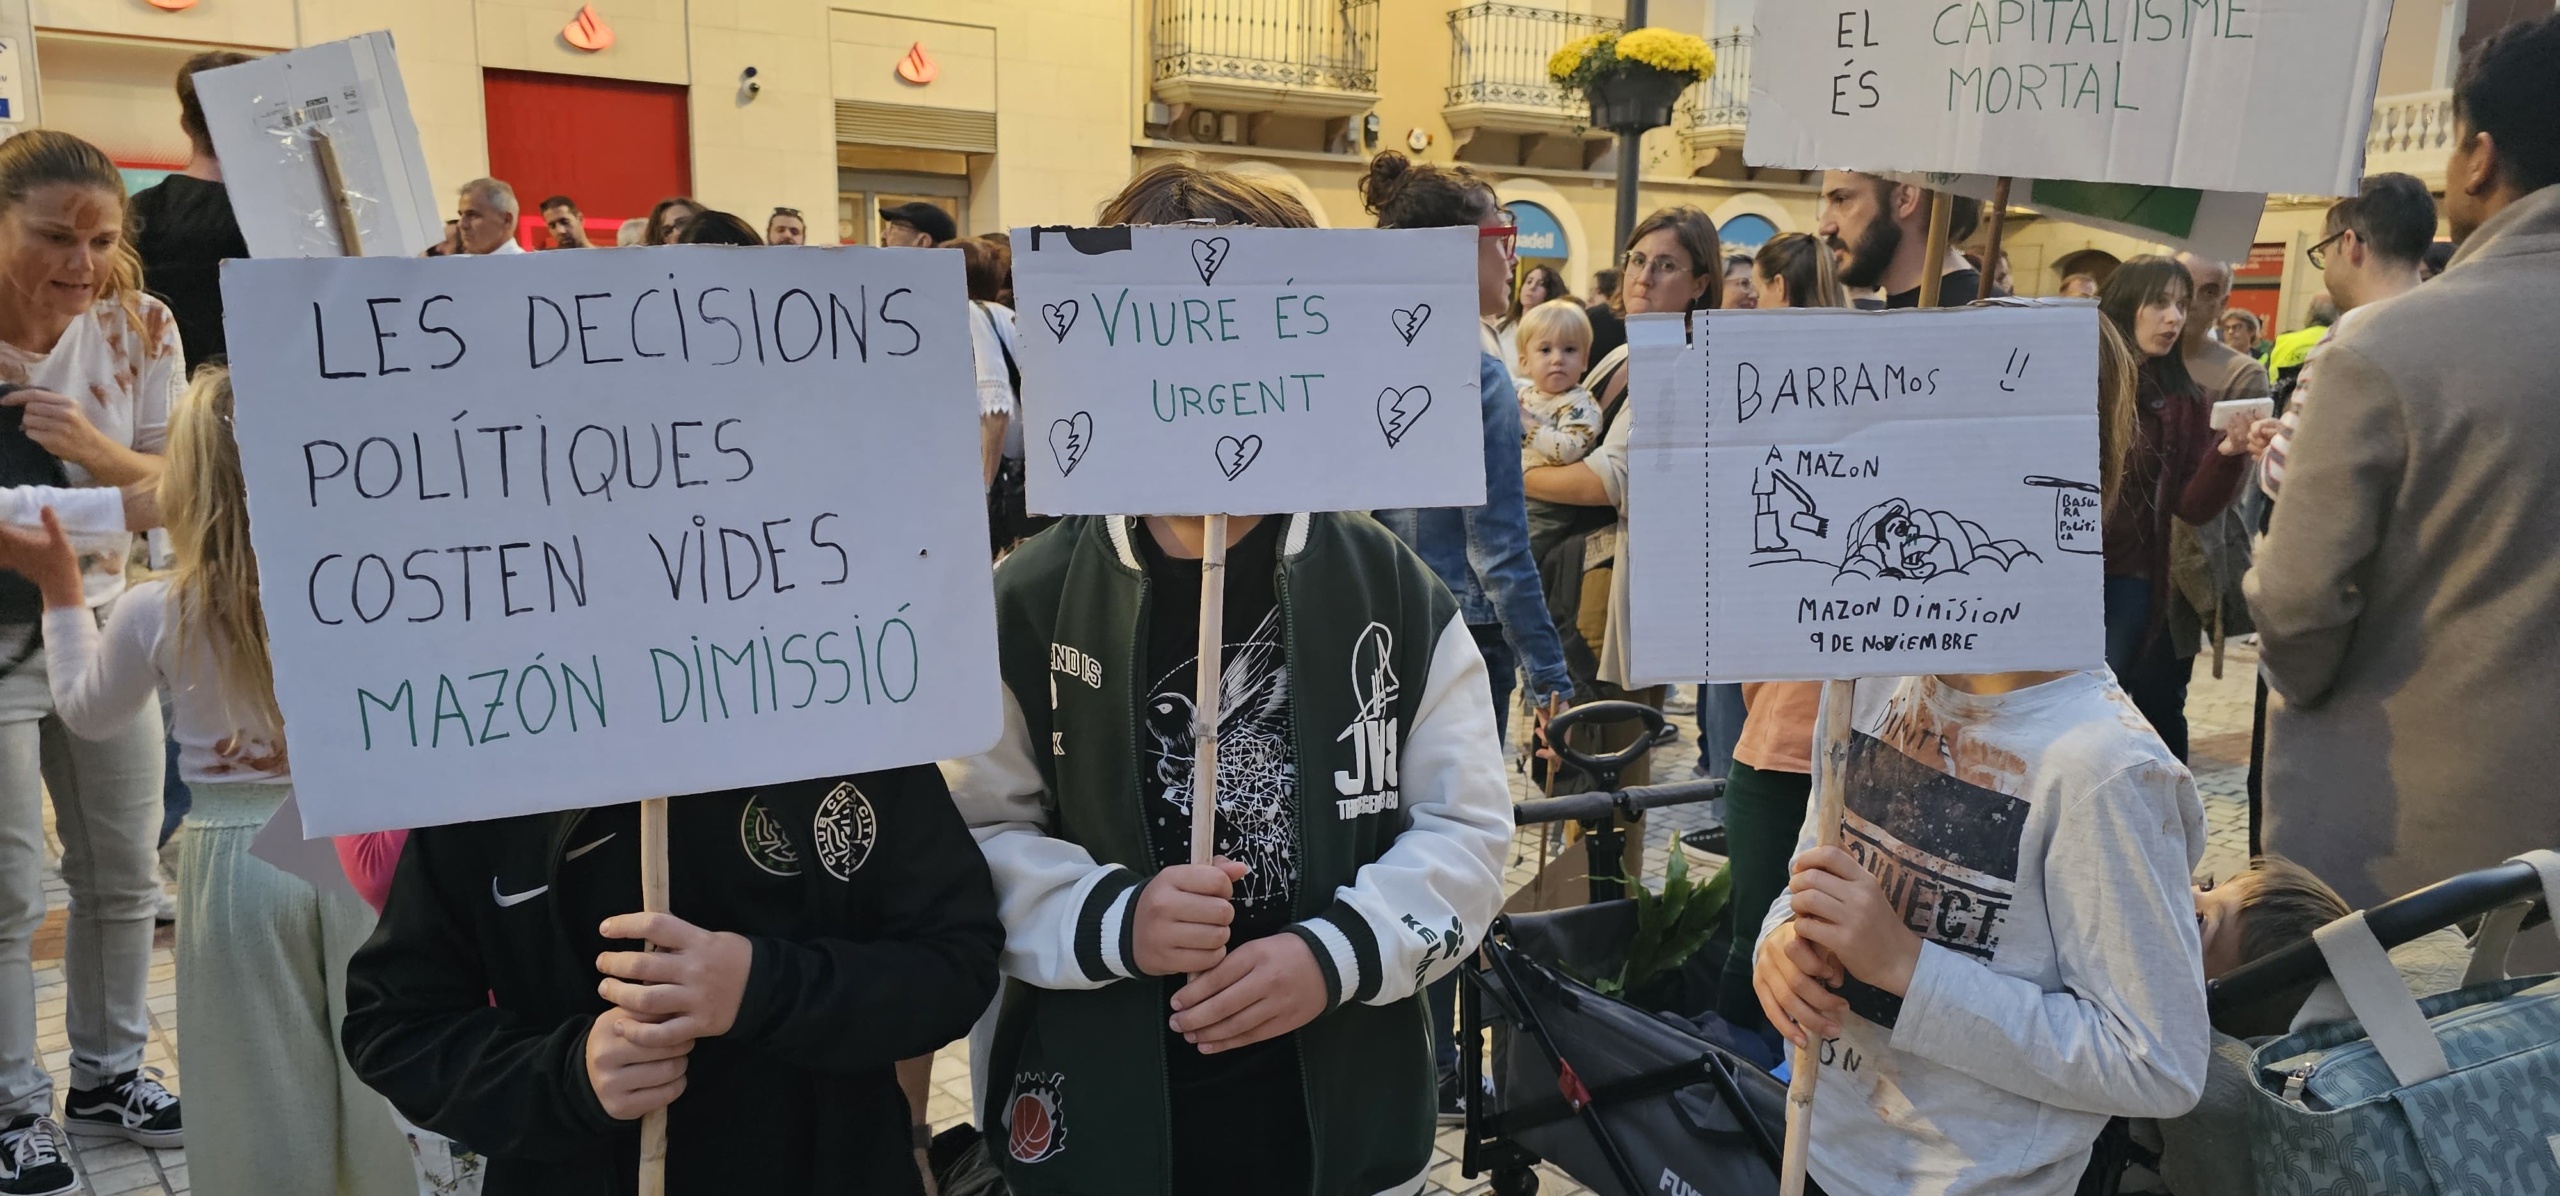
<box><xmin>1152</xmin><ymin>0</ymin><xmax>1380</xmax><ymax>118</ymax></box>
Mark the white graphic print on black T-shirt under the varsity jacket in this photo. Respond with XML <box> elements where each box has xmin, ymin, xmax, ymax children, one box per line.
<box><xmin>1147</xmin><ymin>607</ymin><xmax>1298</xmax><ymax>907</ymax></box>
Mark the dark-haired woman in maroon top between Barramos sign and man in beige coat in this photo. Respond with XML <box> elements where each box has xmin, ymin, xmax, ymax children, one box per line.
<box><xmin>2097</xmin><ymin>256</ymin><xmax>2250</xmax><ymax>761</ymax></box>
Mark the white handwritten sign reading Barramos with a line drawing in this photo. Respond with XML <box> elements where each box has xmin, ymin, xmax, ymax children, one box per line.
<box><xmin>1628</xmin><ymin>305</ymin><xmax>2104</xmax><ymax>684</ymax></box>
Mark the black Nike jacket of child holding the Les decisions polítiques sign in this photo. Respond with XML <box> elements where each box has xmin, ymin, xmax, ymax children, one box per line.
<box><xmin>346</xmin><ymin>766</ymin><xmax>1004</xmax><ymax>1196</ymax></box>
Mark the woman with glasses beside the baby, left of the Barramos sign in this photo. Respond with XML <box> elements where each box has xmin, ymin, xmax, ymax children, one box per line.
<box><xmin>1521</xmin><ymin>205</ymin><xmax>1725</xmax><ymax>876</ymax></box>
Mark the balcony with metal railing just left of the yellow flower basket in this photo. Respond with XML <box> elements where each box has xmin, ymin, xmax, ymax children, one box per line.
<box><xmin>1441</xmin><ymin>3</ymin><xmax>1620</xmax><ymax>141</ymax></box>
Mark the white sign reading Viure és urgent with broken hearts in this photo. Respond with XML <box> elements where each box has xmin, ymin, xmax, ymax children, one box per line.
<box><xmin>1014</xmin><ymin>225</ymin><xmax>1485</xmax><ymax>515</ymax></box>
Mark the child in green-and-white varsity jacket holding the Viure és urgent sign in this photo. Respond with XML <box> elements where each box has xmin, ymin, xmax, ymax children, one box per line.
<box><xmin>945</xmin><ymin>164</ymin><xmax>1510</xmax><ymax>1196</ymax></box>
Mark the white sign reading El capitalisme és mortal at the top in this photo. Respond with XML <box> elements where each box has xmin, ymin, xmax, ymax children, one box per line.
<box><xmin>1743</xmin><ymin>0</ymin><xmax>2391</xmax><ymax>195</ymax></box>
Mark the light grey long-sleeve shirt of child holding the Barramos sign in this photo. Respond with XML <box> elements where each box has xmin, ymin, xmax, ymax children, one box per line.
<box><xmin>1761</xmin><ymin>671</ymin><xmax>2209</xmax><ymax>1196</ymax></box>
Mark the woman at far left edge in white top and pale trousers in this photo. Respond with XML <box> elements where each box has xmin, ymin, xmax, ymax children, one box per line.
<box><xmin>0</xmin><ymin>128</ymin><xmax>184</xmax><ymax>1178</ymax></box>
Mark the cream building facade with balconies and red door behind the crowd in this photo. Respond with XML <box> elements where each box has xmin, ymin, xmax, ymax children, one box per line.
<box><xmin>0</xmin><ymin>0</ymin><xmax>2547</xmax><ymax>328</ymax></box>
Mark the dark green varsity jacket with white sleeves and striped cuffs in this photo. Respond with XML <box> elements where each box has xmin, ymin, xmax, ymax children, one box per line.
<box><xmin>942</xmin><ymin>515</ymin><xmax>1510</xmax><ymax>1196</ymax></box>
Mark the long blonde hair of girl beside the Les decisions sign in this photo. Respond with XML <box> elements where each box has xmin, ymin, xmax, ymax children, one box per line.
<box><xmin>159</xmin><ymin>366</ymin><xmax>284</xmax><ymax>748</ymax></box>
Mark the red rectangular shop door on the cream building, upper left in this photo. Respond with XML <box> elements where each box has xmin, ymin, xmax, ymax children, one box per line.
<box><xmin>481</xmin><ymin>69</ymin><xmax>694</xmax><ymax>246</ymax></box>
